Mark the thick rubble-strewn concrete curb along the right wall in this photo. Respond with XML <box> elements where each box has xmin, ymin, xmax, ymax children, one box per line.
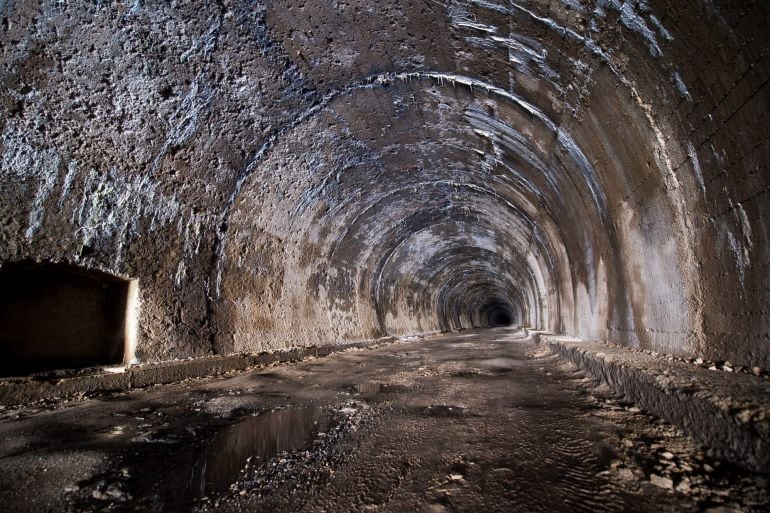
<box><xmin>528</xmin><ymin>331</ymin><xmax>770</xmax><ymax>472</ymax></box>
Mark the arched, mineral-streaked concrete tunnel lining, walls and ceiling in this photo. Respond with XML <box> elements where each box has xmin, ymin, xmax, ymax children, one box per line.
<box><xmin>0</xmin><ymin>0</ymin><xmax>770</xmax><ymax>367</ymax></box>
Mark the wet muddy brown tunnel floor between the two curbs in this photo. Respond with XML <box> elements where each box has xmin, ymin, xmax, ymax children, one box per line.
<box><xmin>0</xmin><ymin>328</ymin><xmax>770</xmax><ymax>513</ymax></box>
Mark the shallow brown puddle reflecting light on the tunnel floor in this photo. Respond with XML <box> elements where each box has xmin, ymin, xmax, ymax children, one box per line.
<box><xmin>188</xmin><ymin>407</ymin><xmax>333</xmax><ymax>498</ymax></box>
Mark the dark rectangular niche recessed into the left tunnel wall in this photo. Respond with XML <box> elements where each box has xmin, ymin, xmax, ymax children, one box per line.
<box><xmin>0</xmin><ymin>262</ymin><xmax>136</xmax><ymax>376</ymax></box>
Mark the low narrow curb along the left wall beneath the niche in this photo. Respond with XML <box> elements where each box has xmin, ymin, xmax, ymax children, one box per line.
<box><xmin>0</xmin><ymin>337</ymin><xmax>397</xmax><ymax>406</ymax></box>
